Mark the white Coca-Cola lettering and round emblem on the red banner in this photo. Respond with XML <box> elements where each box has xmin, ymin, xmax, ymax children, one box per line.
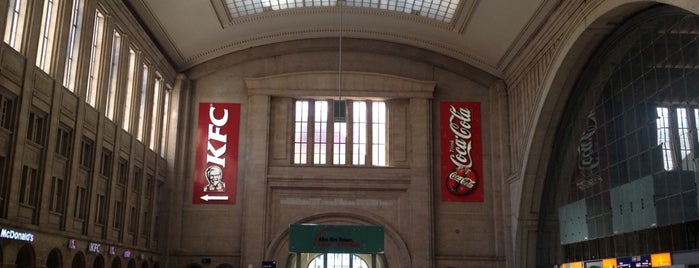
<box><xmin>445</xmin><ymin>105</ymin><xmax>479</xmax><ymax>195</ymax></box>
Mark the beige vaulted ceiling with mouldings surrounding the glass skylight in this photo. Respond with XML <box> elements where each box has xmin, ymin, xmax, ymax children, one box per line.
<box><xmin>125</xmin><ymin>0</ymin><xmax>560</xmax><ymax>77</ymax></box>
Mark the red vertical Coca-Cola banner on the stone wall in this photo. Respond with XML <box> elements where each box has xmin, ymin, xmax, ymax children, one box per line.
<box><xmin>439</xmin><ymin>102</ymin><xmax>483</xmax><ymax>202</ymax></box>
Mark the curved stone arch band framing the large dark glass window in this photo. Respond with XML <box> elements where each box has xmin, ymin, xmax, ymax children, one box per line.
<box><xmin>508</xmin><ymin>0</ymin><xmax>699</xmax><ymax>267</ymax></box>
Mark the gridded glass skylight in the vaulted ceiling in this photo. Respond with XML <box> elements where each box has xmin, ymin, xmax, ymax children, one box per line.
<box><xmin>226</xmin><ymin>0</ymin><xmax>459</xmax><ymax>23</ymax></box>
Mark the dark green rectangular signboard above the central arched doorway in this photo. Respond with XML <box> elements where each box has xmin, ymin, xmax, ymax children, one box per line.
<box><xmin>289</xmin><ymin>224</ymin><xmax>383</xmax><ymax>254</ymax></box>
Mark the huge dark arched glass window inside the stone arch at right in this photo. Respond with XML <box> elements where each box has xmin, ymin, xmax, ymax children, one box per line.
<box><xmin>537</xmin><ymin>6</ymin><xmax>699</xmax><ymax>266</ymax></box>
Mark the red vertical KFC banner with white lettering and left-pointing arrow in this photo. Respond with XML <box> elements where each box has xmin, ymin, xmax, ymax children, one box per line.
<box><xmin>192</xmin><ymin>103</ymin><xmax>240</xmax><ymax>204</ymax></box>
